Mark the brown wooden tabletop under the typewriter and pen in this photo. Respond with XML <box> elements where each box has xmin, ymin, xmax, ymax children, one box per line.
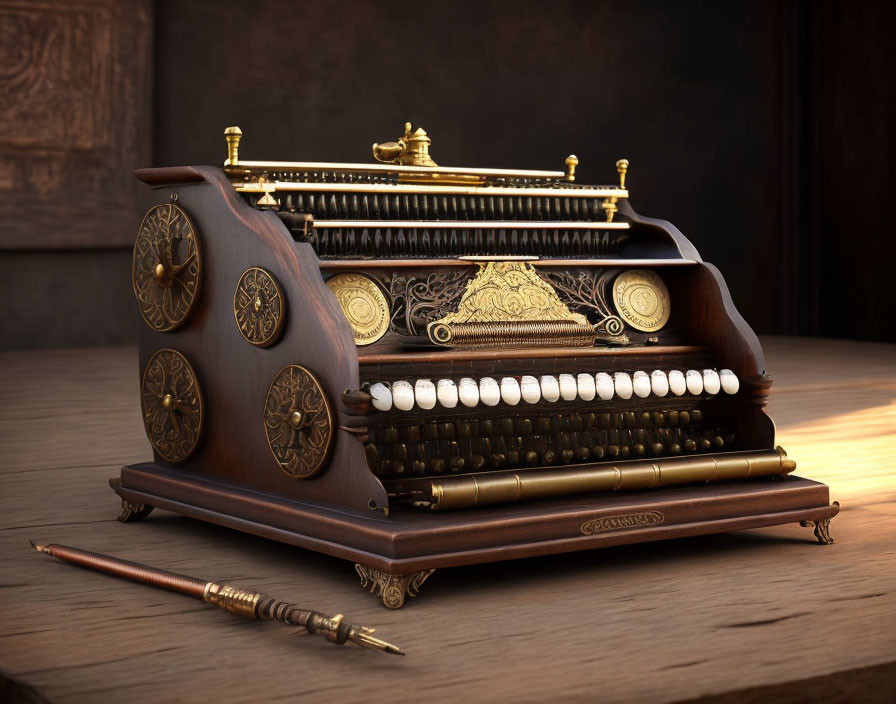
<box><xmin>0</xmin><ymin>338</ymin><xmax>896</xmax><ymax>702</ymax></box>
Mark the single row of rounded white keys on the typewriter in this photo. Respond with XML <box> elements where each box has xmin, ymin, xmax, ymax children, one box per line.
<box><xmin>367</xmin><ymin>369</ymin><xmax>740</xmax><ymax>411</ymax></box>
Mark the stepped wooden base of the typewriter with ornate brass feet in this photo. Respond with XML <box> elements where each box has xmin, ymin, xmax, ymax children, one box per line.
<box><xmin>110</xmin><ymin>463</ymin><xmax>840</xmax><ymax>608</ymax></box>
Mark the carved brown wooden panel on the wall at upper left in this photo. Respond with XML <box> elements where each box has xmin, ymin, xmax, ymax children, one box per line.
<box><xmin>0</xmin><ymin>0</ymin><xmax>152</xmax><ymax>249</ymax></box>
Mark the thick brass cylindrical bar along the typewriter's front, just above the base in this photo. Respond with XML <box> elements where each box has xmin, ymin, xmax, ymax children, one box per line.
<box><xmin>424</xmin><ymin>447</ymin><xmax>796</xmax><ymax>511</ymax></box>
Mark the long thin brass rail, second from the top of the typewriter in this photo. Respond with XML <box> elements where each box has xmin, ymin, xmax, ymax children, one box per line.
<box><xmin>233</xmin><ymin>181</ymin><xmax>628</xmax><ymax>198</ymax></box>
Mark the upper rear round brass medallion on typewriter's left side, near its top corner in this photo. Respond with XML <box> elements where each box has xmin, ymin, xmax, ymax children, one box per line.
<box><xmin>131</xmin><ymin>203</ymin><xmax>202</xmax><ymax>332</ymax></box>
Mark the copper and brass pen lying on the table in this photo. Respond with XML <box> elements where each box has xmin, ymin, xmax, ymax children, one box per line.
<box><xmin>28</xmin><ymin>540</ymin><xmax>404</xmax><ymax>655</ymax></box>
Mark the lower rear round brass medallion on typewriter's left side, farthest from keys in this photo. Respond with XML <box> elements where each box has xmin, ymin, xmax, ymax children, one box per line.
<box><xmin>140</xmin><ymin>349</ymin><xmax>203</xmax><ymax>464</ymax></box>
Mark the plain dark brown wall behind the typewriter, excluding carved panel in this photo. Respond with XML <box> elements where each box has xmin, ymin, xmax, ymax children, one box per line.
<box><xmin>0</xmin><ymin>0</ymin><xmax>896</xmax><ymax>347</ymax></box>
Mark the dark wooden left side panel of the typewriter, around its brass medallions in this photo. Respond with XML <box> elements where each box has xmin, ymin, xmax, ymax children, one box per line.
<box><xmin>123</xmin><ymin>167</ymin><xmax>387</xmax><ymax>513</ymax></box>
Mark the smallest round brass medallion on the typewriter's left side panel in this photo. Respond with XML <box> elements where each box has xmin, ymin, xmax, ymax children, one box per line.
<box><xmin>233</xmin><ymin>267</ymin><xmax>286</xmax><ymax>347</ymax></box>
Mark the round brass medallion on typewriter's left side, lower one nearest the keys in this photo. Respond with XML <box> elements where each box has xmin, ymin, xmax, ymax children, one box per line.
<box><xmin>264</xmin><ymin>364</ymin><xmax>333</xmax><ymax>479</ymax></box>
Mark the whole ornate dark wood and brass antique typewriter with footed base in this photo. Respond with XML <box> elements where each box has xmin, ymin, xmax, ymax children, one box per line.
<box><xmin>112</xmin><ymin>123</ymin><xmax>839</xmax><ymax>608</ymax></box>
